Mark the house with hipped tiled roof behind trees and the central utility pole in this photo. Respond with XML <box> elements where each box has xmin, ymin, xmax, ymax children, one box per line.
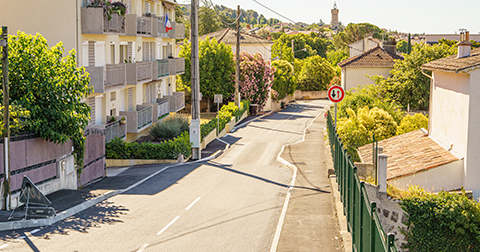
<box><xmin>199</xmin><ymin>28</ymin><xmax>273</xmax><ymax>60</ymax></box>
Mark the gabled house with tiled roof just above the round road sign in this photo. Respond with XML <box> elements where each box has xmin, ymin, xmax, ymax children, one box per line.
<box><xmin>338</xmin><ymin>41</ymin><xmax>403</xmax><ymax>90</ymax></box>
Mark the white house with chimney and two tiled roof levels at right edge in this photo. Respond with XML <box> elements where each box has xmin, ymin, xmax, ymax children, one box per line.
<box><xmin>359</xmin><ymin>32</ymin><xmax>480</xmax><ymax>198</ymax></box>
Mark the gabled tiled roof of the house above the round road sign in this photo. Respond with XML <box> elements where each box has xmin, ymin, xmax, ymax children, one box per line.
<box><xmin>338</xmin><ymin>46</ymin><xmax>403</xmax><ymax>67</ymax></box>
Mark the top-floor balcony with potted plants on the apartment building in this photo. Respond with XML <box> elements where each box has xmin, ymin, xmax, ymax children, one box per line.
<box><xmin>81</xmin><ymin>8</ymin><xmax>125</xmax><ymax>34</ymax></box>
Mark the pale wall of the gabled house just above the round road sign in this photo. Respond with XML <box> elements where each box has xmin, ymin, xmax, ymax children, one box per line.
<box><xmin>342</xmin><ymin>67</ymin><xmax>392</xmax><ymax>91</ymax></box>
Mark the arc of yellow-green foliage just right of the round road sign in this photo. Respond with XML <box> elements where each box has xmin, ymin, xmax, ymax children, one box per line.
<box><xmin>337</xmin><ymin>84</ymin><xmax>404</xmax><ymax>124</ymax></box>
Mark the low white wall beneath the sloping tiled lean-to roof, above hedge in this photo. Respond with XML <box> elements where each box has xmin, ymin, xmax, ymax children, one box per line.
<box><xmin>387</xmin><ymin>160</ymin><xmax>464</xmax><ymax>192</ymax></box>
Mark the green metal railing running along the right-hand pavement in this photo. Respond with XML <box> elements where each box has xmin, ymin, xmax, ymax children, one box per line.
<box><xmin>327</xmin><ymin>113</ymin><xmax>397</xmax><ymax>252</ymax></box>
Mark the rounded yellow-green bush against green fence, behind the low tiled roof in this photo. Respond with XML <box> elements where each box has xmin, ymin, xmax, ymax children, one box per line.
<box><xmin>337</xmin><ymin>107</ymin><xmax>397</xmax><ymax>160</ymax></box>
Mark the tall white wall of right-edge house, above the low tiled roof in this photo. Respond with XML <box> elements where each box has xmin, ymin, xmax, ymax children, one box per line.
<box><xmin>429</xmin><ymin>71</ymin><xmax>466</xmax><ymax>157</ymax></box>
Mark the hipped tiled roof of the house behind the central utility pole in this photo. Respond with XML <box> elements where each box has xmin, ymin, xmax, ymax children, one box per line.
<box><xmin>199</xmin><ymin>28</ymin><xmax>273</xmax><ymax>45</ymax></box>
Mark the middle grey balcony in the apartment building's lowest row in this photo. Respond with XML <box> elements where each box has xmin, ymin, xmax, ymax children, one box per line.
<box><xmin>120</xmin><ymin>105</ymin><xmax>153</xmax><ymax>133</ymax></box>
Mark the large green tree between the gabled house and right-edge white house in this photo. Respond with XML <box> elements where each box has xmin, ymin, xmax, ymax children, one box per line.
<box><xmin>372</xmin><ymin>44</ymin><xmax>456</xmax><ymax>110</ymax></box>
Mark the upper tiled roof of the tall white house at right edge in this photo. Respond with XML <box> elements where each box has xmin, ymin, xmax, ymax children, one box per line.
<box><xmin>421</xmin><ymin>48</ymin><xmax>480</xmax><ymax>73</ymax></box>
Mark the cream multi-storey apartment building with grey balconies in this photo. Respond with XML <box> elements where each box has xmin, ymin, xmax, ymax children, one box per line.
<box><xmin>0</xmin><ymin>0</ymin><xmax>185</xmax><ymax>141</ymax></box>
